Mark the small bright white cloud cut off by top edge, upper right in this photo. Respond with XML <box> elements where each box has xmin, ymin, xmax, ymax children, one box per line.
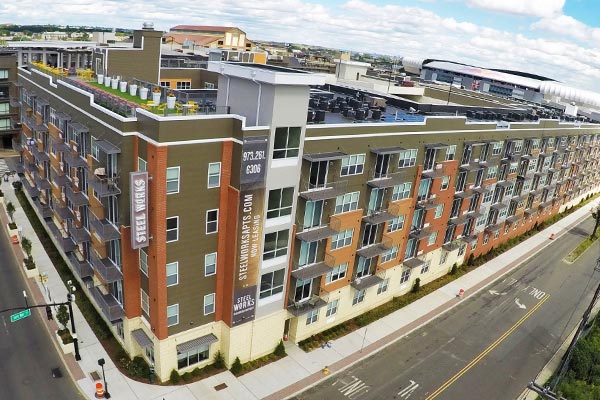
<box><xmin>465</xmin><ymin>0</ymin><xmax>565</xmax><ymax>18</ymax></box>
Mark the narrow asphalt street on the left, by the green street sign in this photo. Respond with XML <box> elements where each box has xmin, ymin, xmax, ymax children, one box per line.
<box><xmin>0</xmin><ymin>225</ymin><xmax>83</xmax><ymax>400</ymax></box>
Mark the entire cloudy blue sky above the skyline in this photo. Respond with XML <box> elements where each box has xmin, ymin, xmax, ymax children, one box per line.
<box><xmin>0</xmin><ymin>0</ymin><xmax>600</xmax><ymax>93</ymax></box>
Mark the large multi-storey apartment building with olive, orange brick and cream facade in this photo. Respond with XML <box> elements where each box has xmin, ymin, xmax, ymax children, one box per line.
<box><xmin>10</xmin><ymin>25</ymin><xmax>600</xmax><ymax>380</ymax></box>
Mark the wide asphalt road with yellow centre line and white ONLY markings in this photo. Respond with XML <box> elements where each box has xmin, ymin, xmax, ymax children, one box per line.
<box><xmin>295</xmin><ymin>219</ymin><xmax>600</xmax><ymax>400</ymax></box>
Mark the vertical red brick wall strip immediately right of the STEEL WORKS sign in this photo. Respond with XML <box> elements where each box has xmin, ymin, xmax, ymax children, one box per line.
<box><xmin>147</xmin><ymin>143</ymin><xmax>169</xmax><ymax>340</ymax></box>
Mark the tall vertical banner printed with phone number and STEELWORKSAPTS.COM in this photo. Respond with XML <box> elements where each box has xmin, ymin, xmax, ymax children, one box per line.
<box><xmin>231</xmin><ymin>136</ymin><xmax>268</xmax><ymax>326</ymax></box>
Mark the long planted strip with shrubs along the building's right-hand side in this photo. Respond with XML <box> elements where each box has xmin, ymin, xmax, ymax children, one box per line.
<box><xmin>298</xmin><ymin>193</ymin><xmax>600</xmax><ymax>351</ymax></box>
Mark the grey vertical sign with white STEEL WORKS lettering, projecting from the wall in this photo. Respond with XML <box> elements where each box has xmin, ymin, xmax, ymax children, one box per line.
<box><xmin>129</xmin><ymin>172</ymin><xmax>150</xmax><ymax>249</ymax></box>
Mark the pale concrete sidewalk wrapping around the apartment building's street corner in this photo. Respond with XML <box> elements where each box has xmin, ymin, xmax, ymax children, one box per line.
<box><xmin>0</xmin><ymin>160</ymin><xmax>599</xmax><ymax>400</ymax></box>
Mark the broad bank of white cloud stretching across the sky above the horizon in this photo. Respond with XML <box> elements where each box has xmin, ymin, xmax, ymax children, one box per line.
<box><xmin>0</xmin><ymin>0</ymin><xmax>600</xmax><ymax>92</ymax></box>
